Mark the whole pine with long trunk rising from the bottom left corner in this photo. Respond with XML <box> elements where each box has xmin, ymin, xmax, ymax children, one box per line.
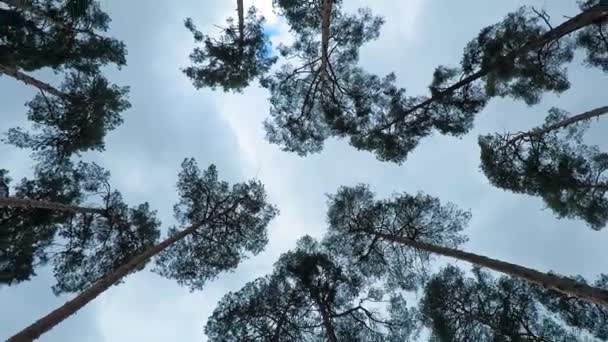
<box><xmin>8</xmin><ymin>159</ymin><xmax>277</xmax><ymax>341</ymax></box>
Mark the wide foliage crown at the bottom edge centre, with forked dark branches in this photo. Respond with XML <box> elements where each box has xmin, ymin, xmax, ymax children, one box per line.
<box><xmin>205</xmin><ymin>237</ymin><xmax>417</xmax><ymax>341</ymax></box>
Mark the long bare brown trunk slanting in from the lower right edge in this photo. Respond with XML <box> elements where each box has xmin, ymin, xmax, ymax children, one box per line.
<box><xmin>368</xmin><ymin>232</ymin><xmax>608</xmax><ymax>308</ymax></box>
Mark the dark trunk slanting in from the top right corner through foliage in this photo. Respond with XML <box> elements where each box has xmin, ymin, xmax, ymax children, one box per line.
<box><xmin>373</xmin><ymin>5</ymin><xmax>608</xmax><ymax>131</ymax></box>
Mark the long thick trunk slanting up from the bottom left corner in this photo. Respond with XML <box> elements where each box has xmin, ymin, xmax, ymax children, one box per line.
<box><xmin>7</xmin><ymin>222</ymin><xmax>203</xmax><ymax>342</ymax></box>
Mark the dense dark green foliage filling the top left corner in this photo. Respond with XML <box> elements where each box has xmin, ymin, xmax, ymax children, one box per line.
<box><xmin>0</xmin><ymin>0</ymin><xmax>126</xmax><ymax>72</ymax></box>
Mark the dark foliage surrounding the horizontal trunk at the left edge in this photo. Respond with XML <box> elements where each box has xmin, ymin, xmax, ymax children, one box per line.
<box><xmin>0</xmin><ymin>161</ymin><xmax>160</xmax><ymax>294</ymax></box>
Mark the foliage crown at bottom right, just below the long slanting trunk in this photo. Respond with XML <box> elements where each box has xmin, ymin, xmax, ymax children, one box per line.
<box><xmin>420</xmin><ymin>266</ymin><xmax>583</xmax><ymax>342</ymax></box>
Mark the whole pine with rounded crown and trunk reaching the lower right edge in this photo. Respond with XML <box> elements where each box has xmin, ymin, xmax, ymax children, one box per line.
<box><xmin>327</xmin><ymin>185</ymin><xmax>608</xmax><ymax>308</ymax></box>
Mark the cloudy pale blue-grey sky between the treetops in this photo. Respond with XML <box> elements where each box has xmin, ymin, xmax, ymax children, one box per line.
<box><xmin>0</xmin><ymin>0</ymin><xmax>608</xmax><ymax>342</ymax></box>
